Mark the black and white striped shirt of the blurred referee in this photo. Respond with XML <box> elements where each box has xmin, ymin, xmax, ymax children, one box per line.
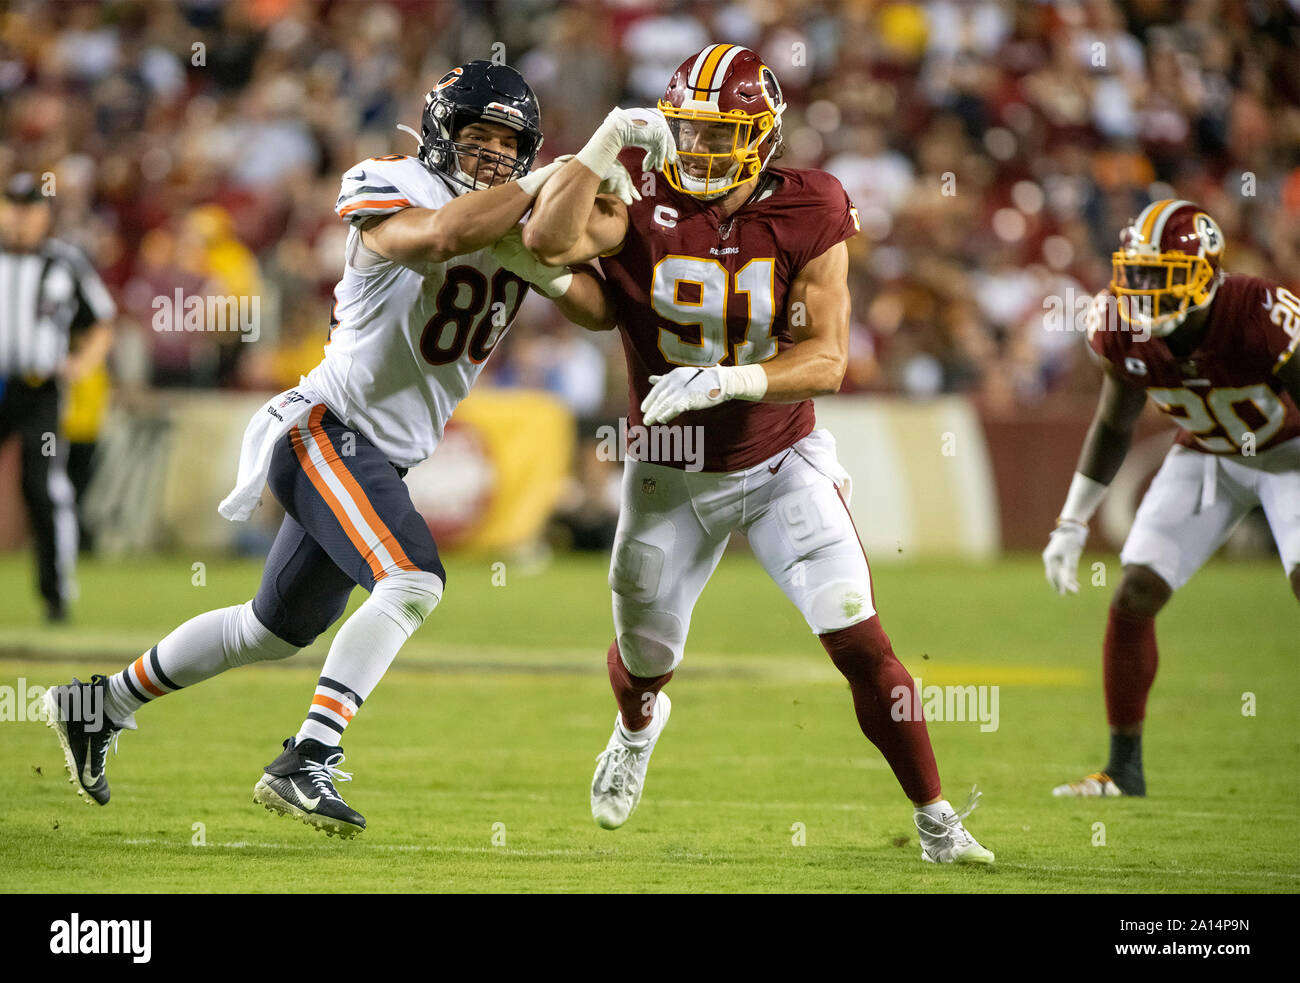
<box><xmin>0</xmin><ymin>239</ymin><xmax>117</xmax><ymax>378</ymax></box>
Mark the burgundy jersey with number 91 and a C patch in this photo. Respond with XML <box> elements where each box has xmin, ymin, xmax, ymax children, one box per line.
<box><xmin>601</xmin><ymin>151</ymin><xmax>858</xmax><ymax>471</ymax></box>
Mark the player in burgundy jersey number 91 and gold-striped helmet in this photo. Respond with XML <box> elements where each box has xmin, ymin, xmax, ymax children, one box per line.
<box><xmin>524</xmin><ymin>44</ymin><xmax>993</xmax><ymax>863</ymax></box>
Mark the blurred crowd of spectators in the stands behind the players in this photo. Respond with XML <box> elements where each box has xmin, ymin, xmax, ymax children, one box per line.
<box><xmin>0</xmin><ymin>0</ymin><xmax>1300</xmax><ymax>419</ymax></box>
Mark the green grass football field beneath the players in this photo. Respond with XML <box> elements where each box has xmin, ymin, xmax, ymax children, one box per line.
<box><xmin>0</xmin><ymin>554</ymin><xmax>1300</xmax><ymax>893</ymax></box>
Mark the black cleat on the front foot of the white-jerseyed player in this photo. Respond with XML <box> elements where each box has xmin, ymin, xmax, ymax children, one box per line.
<box><xmin>252</xmin><ymin>737</ymin><xmax>365</xmax><ymax>840</ymax></box>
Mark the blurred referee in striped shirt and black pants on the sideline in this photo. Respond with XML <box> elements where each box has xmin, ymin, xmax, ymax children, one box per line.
<box><xmin>0</xmin><ymin>174</ymin><xmax>117</xmax><ymax>622</ymax></box>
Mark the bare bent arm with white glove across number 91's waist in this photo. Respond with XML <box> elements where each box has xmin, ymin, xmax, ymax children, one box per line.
<box><xmin>641</xmin><ymin>242</ymin><xmax>849</xmax><ymax>426</ymax></box>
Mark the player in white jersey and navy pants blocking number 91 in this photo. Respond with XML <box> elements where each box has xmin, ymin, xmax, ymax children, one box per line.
<box><xmin>47</xmin><ymin>61</ymin><xmax>631</xmax><ymax>837</ymax></box>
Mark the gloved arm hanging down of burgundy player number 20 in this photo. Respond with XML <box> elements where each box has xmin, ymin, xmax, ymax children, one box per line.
<box><xmin>1043</xmin><ymin>368</ymin><xmax>1147</xmax><ymax>596</ymax></box>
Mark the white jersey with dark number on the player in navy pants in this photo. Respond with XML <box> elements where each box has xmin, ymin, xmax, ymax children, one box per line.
<box><xmin>306</xmin><ymin>156</ymin><xmax>528</xmax><ymax>468</ymax></box>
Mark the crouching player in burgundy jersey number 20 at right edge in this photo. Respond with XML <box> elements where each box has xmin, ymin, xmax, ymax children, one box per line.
<box><xmin>1043</xmin><ymin>199</ymin><xmax>1300</xmax><ymax>796</ymax></box>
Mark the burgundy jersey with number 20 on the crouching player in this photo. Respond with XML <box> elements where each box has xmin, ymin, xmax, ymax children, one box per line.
<box><xmin>1088</xmin><ymin>274</ymin><xmax>1300</xmax><ymax>454</ymax></box>
